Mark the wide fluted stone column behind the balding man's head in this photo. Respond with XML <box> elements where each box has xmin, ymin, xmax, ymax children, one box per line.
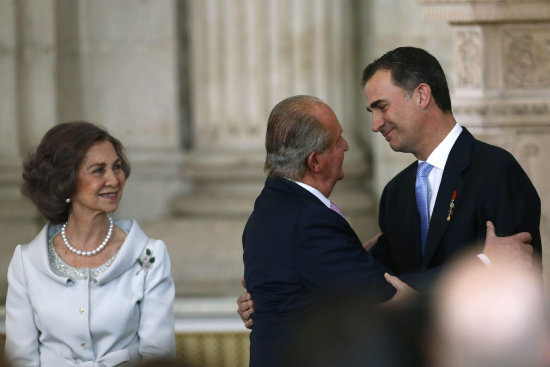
<box><xmin>183</xmin><ymin>0</ymin><xmax>366</xmax><ymax>213</ymax></box>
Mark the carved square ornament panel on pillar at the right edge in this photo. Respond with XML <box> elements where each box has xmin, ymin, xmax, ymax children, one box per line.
<box><xmin>502</xmin><ymin>26</ymin><xmax>550</xmax><ymax>88</ymax></box>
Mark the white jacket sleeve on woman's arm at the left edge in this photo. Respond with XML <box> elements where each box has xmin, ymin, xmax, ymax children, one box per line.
<box><xmin>5</xmin><ymin>245</ymin><xmax>40</xmax><ymax>367</ymax></box>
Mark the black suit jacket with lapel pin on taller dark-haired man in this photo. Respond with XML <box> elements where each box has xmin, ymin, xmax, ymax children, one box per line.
<box><xmin>372</xmin><ymin>128</ymin><xmax>541</xmax><ymax>289</ymax></box>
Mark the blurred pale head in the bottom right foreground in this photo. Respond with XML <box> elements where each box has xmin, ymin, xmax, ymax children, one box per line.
<box><xmin>430</xmin><ymin>256</ymin><xmax>550</xmax><ymax>367</ymax></box>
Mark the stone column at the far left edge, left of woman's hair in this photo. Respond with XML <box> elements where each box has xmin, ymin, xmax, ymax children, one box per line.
<box><xmin>0</xmin><ymin>0</ymin><xmax>57</xmax><ymax>221</ymax></box>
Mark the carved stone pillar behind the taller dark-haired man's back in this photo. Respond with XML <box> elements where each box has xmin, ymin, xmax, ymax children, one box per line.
<box><xmin>419</xmin><ymin>0</ymin><xmax>550</xmax><ymax>284</ymax></box>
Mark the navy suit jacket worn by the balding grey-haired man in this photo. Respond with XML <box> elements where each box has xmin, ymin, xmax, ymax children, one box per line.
<box><xmin>243</xmin><ymin>177</ymin><xmax>395</xmax><ymax>367</ymax></box>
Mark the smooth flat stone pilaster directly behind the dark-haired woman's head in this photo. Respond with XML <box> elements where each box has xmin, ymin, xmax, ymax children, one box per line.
<box><xmin>57</xmin><ymin>0</ymin><xmax>184</xmax><ymax>220</ymax></box>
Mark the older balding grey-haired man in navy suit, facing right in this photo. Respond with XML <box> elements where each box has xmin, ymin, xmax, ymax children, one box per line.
<box><xmin>243</xmin><ymin>96</ymin><xmax>407</xmax><ymax>367</ymax></box>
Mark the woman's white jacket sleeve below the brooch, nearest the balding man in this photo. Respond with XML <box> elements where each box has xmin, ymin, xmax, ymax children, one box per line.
<box><xmin>138</xmin><ymin>240</ymin><xmax>175</xmax><ymax>358</ymax></box>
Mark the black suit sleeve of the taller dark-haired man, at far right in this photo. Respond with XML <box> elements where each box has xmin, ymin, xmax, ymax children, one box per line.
<box><xmin>478</xmin><ymin>153</ymin><xmax>542</xmax><ymax>262</ymax></box>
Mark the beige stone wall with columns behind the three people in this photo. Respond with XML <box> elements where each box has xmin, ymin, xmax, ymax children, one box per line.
<box><xmin>0</xmin><ymin>0</ymin><xmax>550</xmax><ymax>298</ymax></box>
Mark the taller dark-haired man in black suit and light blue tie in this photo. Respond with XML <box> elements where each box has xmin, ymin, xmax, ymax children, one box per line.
<box><xmin>363</xmin><ymin>47</ymin><xmax>541</xmax><ymax>289</ymax></box>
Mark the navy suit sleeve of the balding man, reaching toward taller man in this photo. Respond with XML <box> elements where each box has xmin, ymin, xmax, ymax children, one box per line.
<box><xmin>294</xmin><ymin>205</ymin><xmax>395</xmax><ymax>302</ymax></box>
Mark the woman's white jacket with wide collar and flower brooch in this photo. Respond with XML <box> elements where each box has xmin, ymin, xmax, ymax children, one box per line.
<box><xmin>5</xmin><ymin>220</ymin><xmax>175</xmax><ymax>367</ymax></box>
